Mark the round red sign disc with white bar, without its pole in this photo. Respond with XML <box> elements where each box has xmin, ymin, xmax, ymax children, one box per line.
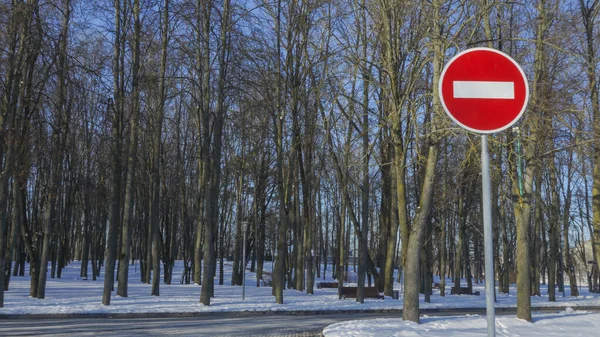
<box><xmin>439</xmin><ymin>48</ymin><xmax>529</xmax><ymax>134</ymax></box>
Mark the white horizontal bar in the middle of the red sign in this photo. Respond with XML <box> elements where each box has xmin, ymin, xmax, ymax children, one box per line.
<box><xmin>453</xmin><ymin>81</ymin><xmax>515</xmax><ymax>99</ymax></box>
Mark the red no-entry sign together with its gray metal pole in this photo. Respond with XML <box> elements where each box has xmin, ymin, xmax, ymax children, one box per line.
<box><xmin>439</xmin><ymin>48</ymin><xmax>529</xmax><ymax>337</ymax></box>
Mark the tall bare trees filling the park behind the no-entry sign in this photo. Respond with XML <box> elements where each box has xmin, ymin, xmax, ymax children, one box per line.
<box><xmin>0</xmin><ymin>0</ymin><xmax>600</xmax><ymax>322</ymax></box>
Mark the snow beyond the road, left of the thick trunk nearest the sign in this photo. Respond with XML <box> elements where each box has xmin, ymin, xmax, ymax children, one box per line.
<box><xmin>0</xmin><ymin>261</ymin><xmax>424</xmax><ymax>315</ymax></box>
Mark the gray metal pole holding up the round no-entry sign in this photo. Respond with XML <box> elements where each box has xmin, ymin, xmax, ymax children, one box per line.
<box><xmin>481</xmin><ymin>135</ymin><xmax>496</xmax><ymax>337</ymax></box>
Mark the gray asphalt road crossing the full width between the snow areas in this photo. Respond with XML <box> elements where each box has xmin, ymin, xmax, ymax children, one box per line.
<box><xmin>0</xmin><ymin>307</ymin><xmax>600</xmax><ymax>337</ymax></box>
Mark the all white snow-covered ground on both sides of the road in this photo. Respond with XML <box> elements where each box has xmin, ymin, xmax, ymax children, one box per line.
<box><xmin>0</xmin><ymin>261</ymin><xmax>600</xmax><ymax>336</ymax></box>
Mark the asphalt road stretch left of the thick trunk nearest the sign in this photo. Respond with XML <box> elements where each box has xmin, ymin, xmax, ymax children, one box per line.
<box><xmin>0</xmin><ymin>313</ymin><xmax>399</xmax><ymax>337</ymax></box>
